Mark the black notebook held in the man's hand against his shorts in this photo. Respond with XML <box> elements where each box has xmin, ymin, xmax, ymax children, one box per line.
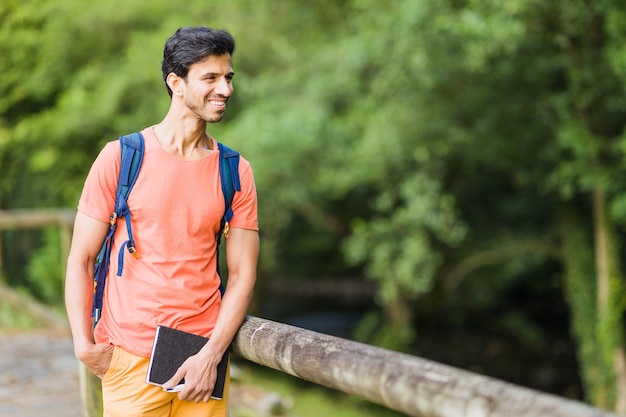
<box><xmin>146</xmin><ymin>326</ymin><xmax>228</xmax><ymax>400</ymax></box>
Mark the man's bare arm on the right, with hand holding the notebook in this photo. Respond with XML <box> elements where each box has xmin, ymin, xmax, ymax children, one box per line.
<box><xmin>163</xmin><ymin>228</ymin><xmax>259</xmax><ymax>402</ymax></box>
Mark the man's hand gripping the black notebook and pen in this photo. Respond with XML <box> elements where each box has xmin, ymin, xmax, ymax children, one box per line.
<box><xmin>163</xmin><ymin>351</ymin><xmax>221</xmax><ymax>403</ymax></box>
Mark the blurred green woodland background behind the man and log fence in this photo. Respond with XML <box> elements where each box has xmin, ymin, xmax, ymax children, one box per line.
<box><xmin>0</xmin><ymin>0</ymin><xmax>626</xmax><ymax>415</ymax></box>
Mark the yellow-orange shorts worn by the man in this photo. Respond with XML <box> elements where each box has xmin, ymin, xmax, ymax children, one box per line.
<box><xmin>102</xmin><ymin>346</ymin><xmax>230</xmax><ymax>417</ymax></box>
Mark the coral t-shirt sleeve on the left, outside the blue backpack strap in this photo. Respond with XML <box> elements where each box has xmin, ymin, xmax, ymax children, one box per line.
<box><xmin>78</xmin><ymin>141</ymin><xmax>121</xmax><ymax>223</ymax></box>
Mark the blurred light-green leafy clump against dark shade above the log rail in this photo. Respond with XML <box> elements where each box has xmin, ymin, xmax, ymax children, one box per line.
<box><xmin>346</xmin><ymin>171</ymin><xmax>465</xmax><ymax>304</ymax></box>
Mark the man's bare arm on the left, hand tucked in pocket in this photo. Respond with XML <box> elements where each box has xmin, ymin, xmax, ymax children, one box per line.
<box><xmin>65</xmin><ymin>211</ymin><xmax>112</xmax><ymax>377</ymax></box>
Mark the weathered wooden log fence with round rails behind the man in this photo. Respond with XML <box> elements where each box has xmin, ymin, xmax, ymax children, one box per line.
<box><xmin>0</xmin><ymin>210</ymin><xmax>616</xmax><ymax>417</ymax></box>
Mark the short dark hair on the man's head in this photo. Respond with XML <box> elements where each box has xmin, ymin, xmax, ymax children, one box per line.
<box><xmin>161</xmin><ymin>26</ymin><xmax>235</xmax><ymax>97</ymax></box>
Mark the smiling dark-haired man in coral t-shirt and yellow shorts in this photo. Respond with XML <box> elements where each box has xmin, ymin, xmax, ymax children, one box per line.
<box><xmin>65</xmin><ymin>27</ymin><xmax>259</xmax><ymax>417</ymax></box>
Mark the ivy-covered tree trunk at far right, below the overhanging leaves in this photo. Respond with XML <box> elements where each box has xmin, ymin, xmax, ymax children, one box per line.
<box><xmin>560</xmin><ymin>191</ymin><xmax>626</xmax><ymax>414</ymax></box>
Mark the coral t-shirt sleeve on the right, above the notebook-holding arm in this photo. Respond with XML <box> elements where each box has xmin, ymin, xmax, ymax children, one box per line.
<box><xmin>230</xmin><ymin>157</ymin><xmax>259</xmax><ymax>230</ymax></box>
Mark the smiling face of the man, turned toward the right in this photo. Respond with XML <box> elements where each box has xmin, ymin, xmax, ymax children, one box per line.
<box><xmin>184</xmin><ymin>54</ymin><xmax>235</xmax><ymax>123</ymax></box>
